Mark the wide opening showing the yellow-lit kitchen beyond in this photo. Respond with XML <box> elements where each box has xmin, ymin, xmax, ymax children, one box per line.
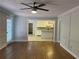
<box><xmin>28</xmin><ymin>20</ymin><xmax>55</xmax><ymax>41</ymax></box>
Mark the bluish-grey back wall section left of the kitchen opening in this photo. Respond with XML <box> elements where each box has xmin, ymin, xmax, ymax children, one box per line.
<box><xmin>15</xmin><ymin>16</ymin><xmax>28</xmax><ymax>41</ymax></box>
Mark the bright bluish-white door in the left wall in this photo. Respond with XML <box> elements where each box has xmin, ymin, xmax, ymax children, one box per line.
<box><xmin>7</xmin><ymin>18</ymin><xmax>13</xmax><ymax>43</ymax></box>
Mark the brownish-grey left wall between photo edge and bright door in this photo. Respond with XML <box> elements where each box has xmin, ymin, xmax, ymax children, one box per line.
<box><xmin>0</xmin><ymin>7</ymin><xmax>14</xmax><ymax>49</ymax></box>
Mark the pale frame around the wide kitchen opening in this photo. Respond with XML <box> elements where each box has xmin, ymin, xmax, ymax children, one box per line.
<box><xmin>27</xmin><ymin>18</ymin><xmax>58</xmax><ymax>42</ymax></box>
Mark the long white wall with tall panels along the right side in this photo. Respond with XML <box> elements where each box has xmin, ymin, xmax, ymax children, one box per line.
<box><xmin>59</xmin><ymin>6</ymin><xmax>79</xmax><ymax>59</ymax></box>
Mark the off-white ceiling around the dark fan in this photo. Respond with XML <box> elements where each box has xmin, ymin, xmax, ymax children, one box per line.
<box><xmin>0</xmin><ymin>0</ymin><xmax>79</xmax><ymax>17</ymax></box>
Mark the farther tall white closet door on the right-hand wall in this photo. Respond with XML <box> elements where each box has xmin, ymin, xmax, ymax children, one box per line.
<box><xmin>60</xmin><ymin>15</ymin><xmax>70</xmax><ymax>48</ymax></box>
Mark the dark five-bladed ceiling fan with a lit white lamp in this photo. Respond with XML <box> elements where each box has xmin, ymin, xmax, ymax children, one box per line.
<box><xmin>21</xmin><ymin>2</ymin><xmax>49</xmax><ymax>13</ymax></box>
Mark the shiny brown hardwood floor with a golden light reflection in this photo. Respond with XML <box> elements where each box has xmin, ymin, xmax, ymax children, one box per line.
<box><xmin>0</xmin><ymin>41</ymin><xmax>75</xmax><ymax>59</ymax></box>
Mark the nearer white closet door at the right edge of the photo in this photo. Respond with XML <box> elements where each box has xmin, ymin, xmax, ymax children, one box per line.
<box><xmin>70</xmin><ymin>9</ymin><xmax>79</xmax><ymax>57</ymax></box>
